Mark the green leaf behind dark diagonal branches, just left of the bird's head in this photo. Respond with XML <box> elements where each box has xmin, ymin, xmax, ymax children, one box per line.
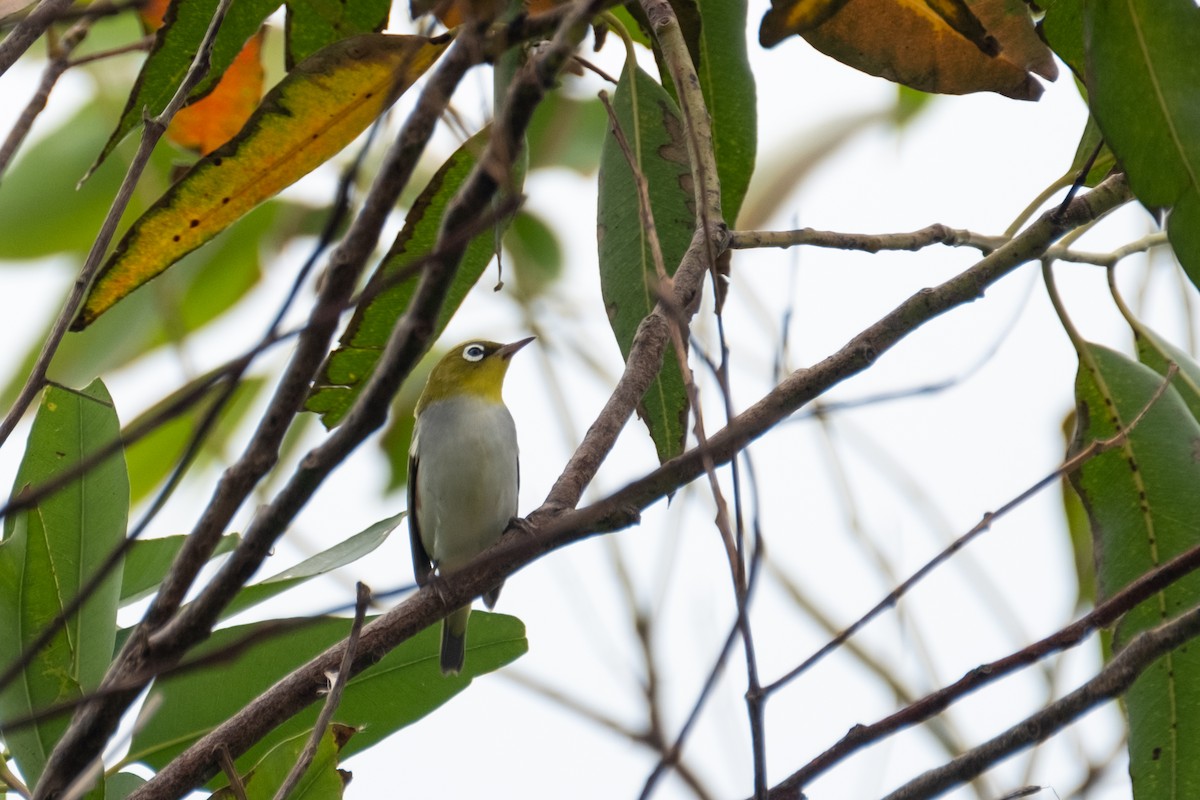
<box><xmin>305</xmin><ymin>128</ymin><xmax>505</xmax><ymax>428</ymax></box>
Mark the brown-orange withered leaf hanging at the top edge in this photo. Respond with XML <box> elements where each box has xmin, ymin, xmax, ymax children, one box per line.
<box><xmin>758</xmin><ymin>0</ymin><xmax>1058</xmax><ymax>100</ymax></box>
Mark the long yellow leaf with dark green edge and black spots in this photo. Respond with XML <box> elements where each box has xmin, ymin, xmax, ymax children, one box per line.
<box><xmin>72</xmin><ymin>34</ymin><xmax>449</xmax><ymax>330</ymax></box>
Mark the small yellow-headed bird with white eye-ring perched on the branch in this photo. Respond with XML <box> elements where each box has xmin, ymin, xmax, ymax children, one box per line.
<box><xmin>408</xmin><ymin>336</ymin><xmax>534</xmax><ymax>675</ymax></box>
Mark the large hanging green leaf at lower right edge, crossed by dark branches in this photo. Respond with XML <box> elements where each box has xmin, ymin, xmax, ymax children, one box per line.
<box><xmin>1070</xmin><ymin>344</ymin><xmax>1200</xmax><ymax>800</ymax></box>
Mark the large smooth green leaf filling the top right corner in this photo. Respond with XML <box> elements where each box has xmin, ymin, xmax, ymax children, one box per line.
<box><xmin>1084</xmin><ymin>0</ymin><xmax>1200</xmax><ymax>287</ymax></box>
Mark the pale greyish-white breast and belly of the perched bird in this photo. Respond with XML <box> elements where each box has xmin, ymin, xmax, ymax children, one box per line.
<box><xmin>413</xmin><ymin>397</ymin><xmax>518</xmax><ymax>573</ymax></box>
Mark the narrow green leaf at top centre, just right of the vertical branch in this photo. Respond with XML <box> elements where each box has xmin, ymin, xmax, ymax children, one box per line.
<box><xmin>696</xmin><ymin>0</ymin><xmax>758</xmax><ymax>221</ymax></box>
